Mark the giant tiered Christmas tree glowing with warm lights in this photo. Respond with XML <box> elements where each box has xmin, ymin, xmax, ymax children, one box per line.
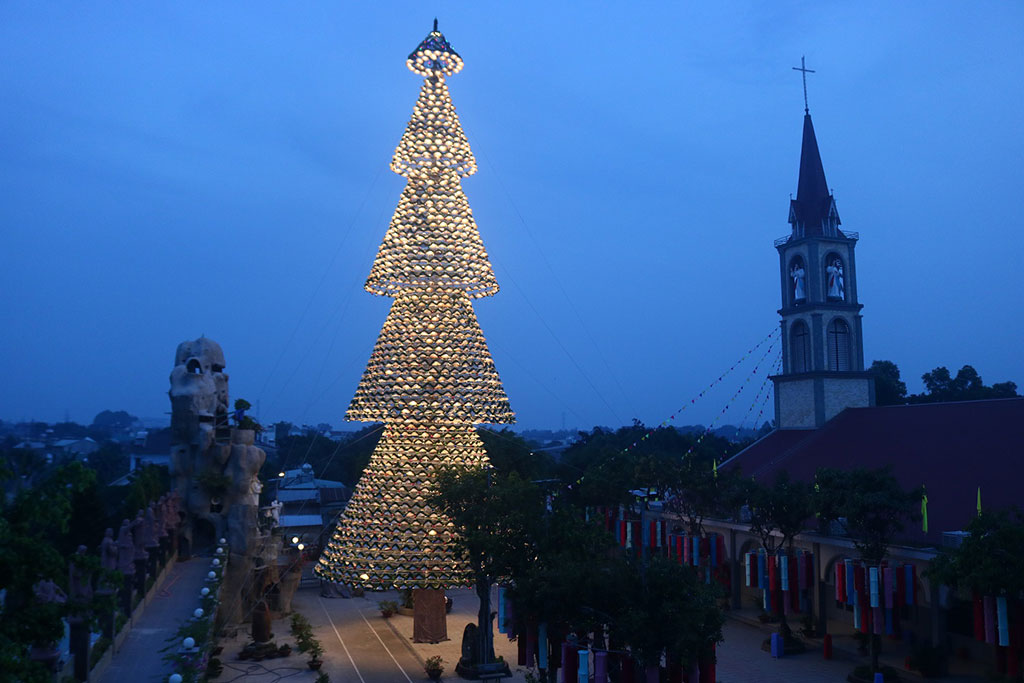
<box><xmin>314</xmin><ymin>23</ymin><xmax>514</xmax><ymax>590</ymax></box>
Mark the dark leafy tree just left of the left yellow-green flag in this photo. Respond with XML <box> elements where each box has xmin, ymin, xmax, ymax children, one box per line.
<box><xmin>814</xmin><ymin>467</ymin><xmax>924</xmax><ymax>671</ymax></box>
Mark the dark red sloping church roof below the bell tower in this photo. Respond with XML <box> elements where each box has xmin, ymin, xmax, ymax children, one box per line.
<box><xmin>721</xmin><ymin>398</ymin><xmax>1024</xmax><ymax>546</ymax></box>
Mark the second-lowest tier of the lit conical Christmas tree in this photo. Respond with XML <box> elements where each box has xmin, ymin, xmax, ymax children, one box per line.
<box><xmin>345</xmin><ymin>289</ymin><xmax>514</xmax><ymax>424</ymax></box>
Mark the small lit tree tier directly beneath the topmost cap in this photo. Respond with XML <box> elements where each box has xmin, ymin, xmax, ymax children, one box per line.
<box><xmin>391</xmin><ymin>76</ymin><xmax>476</xmax><ymax>177</ymax></box>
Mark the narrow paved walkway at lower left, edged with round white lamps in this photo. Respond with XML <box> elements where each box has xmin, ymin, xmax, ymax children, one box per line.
<box><xmin>99</xmin><ymin>557</ymin><xmax>210</xmax><ymax>683</ymax></box>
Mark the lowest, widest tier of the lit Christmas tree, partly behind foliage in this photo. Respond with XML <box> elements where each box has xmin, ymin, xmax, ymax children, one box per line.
<box><xmin>314</xmin><ymin>422</ymin><xmax>487</xmax><ymax>590</ymax></box>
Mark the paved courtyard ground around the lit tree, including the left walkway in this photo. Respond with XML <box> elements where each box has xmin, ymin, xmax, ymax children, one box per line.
<box><xmin>110</xmin><ymin>581</ymin><xmax>981</xmax><ymax>683</ymax></box>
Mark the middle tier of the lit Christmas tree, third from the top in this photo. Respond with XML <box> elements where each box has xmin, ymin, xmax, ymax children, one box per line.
<box><xmin>366</xmin><ymin>170</ymin><xmax>498</xmax><ymax>298</ymax></box>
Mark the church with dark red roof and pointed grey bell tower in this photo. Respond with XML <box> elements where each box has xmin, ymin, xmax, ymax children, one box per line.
<box><xmin>706</xmin><ymin>96</ymin><xmax>1024</xmax><ymax>656</ymax></box>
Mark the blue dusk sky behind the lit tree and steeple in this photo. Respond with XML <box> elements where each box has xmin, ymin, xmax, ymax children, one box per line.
<box><xmin>0</xmin><ymin>0</ymin><xmax>1024</xmax><ymax>428</ymax></box>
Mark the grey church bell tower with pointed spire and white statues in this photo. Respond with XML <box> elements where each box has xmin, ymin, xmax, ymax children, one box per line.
<box><xmin>772</xmin><ymin>69</ymin><xmax>874</xmax><ymax>429</ymax></box>
